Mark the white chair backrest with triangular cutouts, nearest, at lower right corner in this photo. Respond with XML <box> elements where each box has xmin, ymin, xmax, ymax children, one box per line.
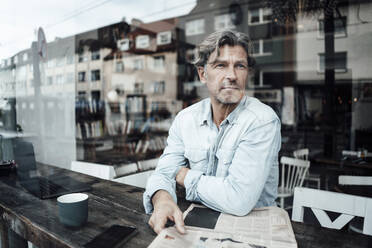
<box><xmin>292</xmin><ymin>187</ymin><xmax>372</xmax><ymax>235</ymax></box>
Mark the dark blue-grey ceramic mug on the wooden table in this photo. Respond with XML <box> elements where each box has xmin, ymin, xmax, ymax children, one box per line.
<box><xmin>57</xmin><ymin>193</ymin><xmax>88</xmax><ymax>227</ymax></box>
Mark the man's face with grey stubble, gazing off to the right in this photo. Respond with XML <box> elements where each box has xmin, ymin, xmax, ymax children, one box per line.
<box><xmin>198</xmin><ymin>45</ymin><xmax>248</xmax><ymax>104</ymax></box>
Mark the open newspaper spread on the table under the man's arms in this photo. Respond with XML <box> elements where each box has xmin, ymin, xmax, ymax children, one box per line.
<box><xmin>149</xmin><ymin>204</ymin><xmax>297</xmax><ymax>248</ymax></box>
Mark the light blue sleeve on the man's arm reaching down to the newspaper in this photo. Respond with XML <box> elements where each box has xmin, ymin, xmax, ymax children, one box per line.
<box><xmin>143</xmin><ymin>117</ymin><xmax>186</xmax><ymax>214</ymax></box>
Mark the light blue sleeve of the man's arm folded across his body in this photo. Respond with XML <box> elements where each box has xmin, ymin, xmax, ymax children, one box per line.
<box><xmin>185</xmin><ymin>118</ymin><xmax>281</xmax><ymax>216</ymax></box>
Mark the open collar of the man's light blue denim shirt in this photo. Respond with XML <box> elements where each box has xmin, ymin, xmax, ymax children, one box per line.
<box><xmin>199</xmin><ymin>96</ymin><xmax>247</xmax><ymax>126</ymax></box>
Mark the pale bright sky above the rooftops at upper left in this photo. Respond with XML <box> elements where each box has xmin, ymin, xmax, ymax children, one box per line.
<box><xmin>0</xmin><ymin>0</ymin><xmax>196</xmax><ymax>60</ymax></box>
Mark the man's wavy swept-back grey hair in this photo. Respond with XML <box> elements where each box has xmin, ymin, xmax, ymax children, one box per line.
<box><xmin>193</xmin><ymin>30</ymin><xmax>255</xmax><ymax>69</ymax></box>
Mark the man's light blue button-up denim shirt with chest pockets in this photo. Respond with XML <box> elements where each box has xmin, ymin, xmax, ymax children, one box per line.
<box><xmin>143</xmin><ymin>96</ymin><xmax>281</xmax><ymax>216</ymax></box>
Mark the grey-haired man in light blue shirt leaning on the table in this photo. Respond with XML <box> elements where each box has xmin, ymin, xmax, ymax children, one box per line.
<box><xmin>143</xmin><ymin>31</ymin><xmax>281</xmax><ymax>233</ymax></box>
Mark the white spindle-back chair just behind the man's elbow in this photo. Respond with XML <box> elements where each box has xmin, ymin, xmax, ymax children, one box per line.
<box><xmin>278</xmin><ymin>156</ymin><xmax>310</xmax><ymax>208</ymax></box>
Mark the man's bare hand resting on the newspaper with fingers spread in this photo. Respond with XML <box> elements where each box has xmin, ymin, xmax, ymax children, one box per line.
<box><xmin>149</xmin><ymin>190</ymin><xmax>186</xmax><ymax>234</ymax></box>
